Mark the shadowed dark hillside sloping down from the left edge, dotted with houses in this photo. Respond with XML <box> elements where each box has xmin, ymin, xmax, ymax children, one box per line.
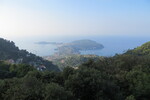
<box><xmin>0</xmin><ymin>38</ymin><xmax>59</xmax><ymax>71</ymax></box>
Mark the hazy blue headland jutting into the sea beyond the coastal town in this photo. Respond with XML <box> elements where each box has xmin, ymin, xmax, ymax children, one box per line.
<box><xmin>56</xmin><ymin>39</ymin><xmax>104</xmax><ymax>55</ymax></box>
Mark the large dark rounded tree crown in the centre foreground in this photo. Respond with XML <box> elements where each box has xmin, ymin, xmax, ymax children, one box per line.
<box><xmin>65</xmin><ymin>67</ymin><xmax>119</xmax><ymax>100</ymax></box>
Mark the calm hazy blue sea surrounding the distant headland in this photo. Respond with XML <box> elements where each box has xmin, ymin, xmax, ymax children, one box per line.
<box><xmin>13</xmin><ymin>36</ymin><xmax>150</xmax><ymax>57</ymax></box>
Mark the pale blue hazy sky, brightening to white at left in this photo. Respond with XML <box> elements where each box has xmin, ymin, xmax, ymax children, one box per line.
<box><xmin>0</xmin><ymin>0</ymin><xmax>150</xmax><ymax>38</ymax></box>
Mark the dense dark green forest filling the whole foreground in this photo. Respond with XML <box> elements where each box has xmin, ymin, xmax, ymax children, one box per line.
<box><xmin>0</xmin><ymin>43</ymin><xmax>150</xmax><ymax>100</ymax></box>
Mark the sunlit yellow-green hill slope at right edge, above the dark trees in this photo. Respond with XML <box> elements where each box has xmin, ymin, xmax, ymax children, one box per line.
<box><xmin>125</xmin><ymin>42</ymin><xmax>150</xmax><ymax>56</ymax></box>
